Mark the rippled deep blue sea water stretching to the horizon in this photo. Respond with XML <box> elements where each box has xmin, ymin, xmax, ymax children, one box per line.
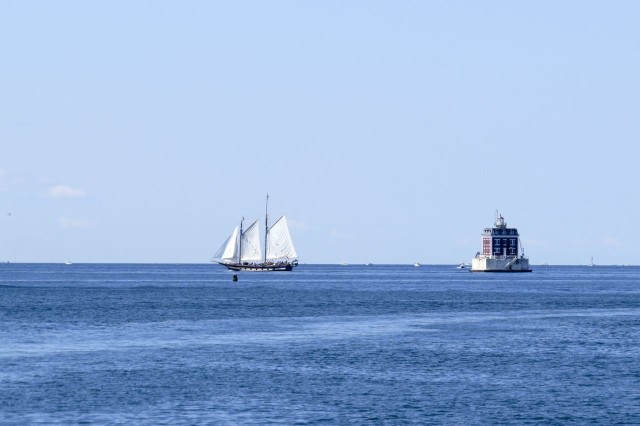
<box><xmin>0</xmin><ymin>264</ymin><xmax>640</xmax><ymax>425</ymax></box>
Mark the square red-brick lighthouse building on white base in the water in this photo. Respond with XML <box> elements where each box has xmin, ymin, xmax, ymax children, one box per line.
<box><xmin>470</xmin><ymin>211</ymin><xmax>531</xmax><ymax>272</ymax></box>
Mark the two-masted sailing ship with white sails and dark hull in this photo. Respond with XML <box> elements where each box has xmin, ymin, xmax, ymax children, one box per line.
<box><xmin>212</xmin><ymin>195</ymin><xmax>298</xmax><ymax>272</ymax></box>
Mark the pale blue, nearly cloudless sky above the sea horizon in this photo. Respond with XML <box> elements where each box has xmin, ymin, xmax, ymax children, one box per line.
<box><xmin>0</xmin><ymin>0</ymin><xmax>640</xmax><ymax>265</ymax></box>
